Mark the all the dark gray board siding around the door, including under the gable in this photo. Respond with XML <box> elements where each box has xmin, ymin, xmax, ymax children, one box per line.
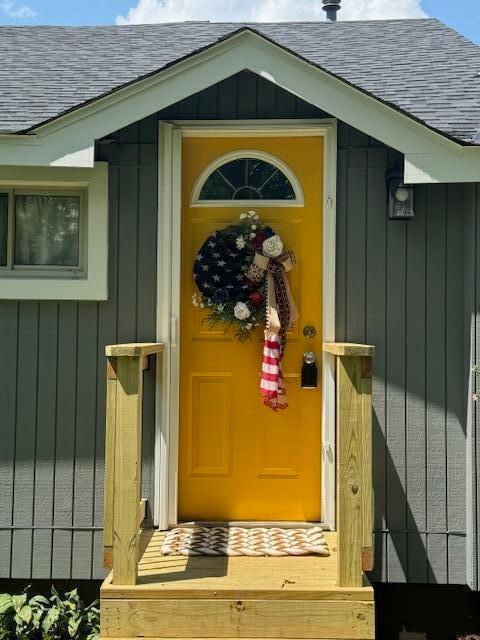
<box><xmin>0</xmin><ymin>72</ymin><xmax>474</xmax><ymax>586</ymax></box>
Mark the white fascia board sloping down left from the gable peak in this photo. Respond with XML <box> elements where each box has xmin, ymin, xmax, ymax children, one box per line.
<box><xmin>0</xmin><ymin>33</ymin><xmax>246</xmax><ymax>167</ymax></box>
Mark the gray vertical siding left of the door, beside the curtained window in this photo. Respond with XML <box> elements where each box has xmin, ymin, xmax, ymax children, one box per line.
<box><xmin>0</xmin><ymin>117</ymin><xmax>157</xmax><ymax>579</ymax></box>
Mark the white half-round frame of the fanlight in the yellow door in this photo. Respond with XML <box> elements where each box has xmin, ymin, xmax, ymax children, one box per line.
<box><xmin>190</xmin><ymin>149</ymin><xmax>304</xmax><ymax>208</ymax></box>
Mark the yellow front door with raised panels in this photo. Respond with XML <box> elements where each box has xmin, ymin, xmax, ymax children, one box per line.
<box><xmin>178</xmin><ymin>137</ymin><xmax>323</xmax><ymax>521</ymax></box>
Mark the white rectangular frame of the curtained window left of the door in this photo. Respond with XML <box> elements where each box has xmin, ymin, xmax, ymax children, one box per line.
<box><xmin>0</xmin><ymin>162</ymin><xmax>108</xmax><ymax>300</ymax></box>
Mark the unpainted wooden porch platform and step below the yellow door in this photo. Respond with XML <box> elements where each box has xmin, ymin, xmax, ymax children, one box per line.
<box><xmin>101</xmin><ymin>532</ymin><xmax>374</xmax><ymax>640</ymax></box>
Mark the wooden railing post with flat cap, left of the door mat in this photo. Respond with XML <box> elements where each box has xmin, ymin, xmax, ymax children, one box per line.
<box><xmin>104</xmin><ymin>343</ymin><xmax>163</xmax><ymax>585</ymax></box>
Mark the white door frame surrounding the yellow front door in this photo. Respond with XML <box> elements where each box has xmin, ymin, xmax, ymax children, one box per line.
<box><xmin>153</xmin><ymin>118</ymin><xmax>337</xmax><ymax>529</ymax></box>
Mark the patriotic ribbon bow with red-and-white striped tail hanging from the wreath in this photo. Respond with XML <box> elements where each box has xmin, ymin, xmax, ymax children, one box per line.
<box><xmin>253</xmin><ymin>252</ymin><xmax>298</xmax><ymax>411</ymax></box>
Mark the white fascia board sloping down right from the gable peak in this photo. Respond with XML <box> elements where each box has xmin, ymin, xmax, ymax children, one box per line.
<box><xmin>244</xmin><ymin>36</ymin><xmax>480</xmax><ymax>183</ymax></box>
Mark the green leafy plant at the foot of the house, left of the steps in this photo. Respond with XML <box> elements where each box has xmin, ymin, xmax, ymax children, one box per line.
<box><xmin>0</xmin><ymin>587</ymin><xmax>100</xmax><ymax>640</ymax></box>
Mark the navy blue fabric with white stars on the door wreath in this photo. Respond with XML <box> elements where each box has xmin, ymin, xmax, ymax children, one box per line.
<box><xmin>193</xmin><ymin>227</ymin><xmax>249</xmax><ymax>302</ymax></box>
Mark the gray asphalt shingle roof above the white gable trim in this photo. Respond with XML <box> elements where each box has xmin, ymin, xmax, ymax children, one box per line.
<box><xmin>0</xmin><ymin>19</ymin><xmax>480</xmax><ymax>143</ymax></box>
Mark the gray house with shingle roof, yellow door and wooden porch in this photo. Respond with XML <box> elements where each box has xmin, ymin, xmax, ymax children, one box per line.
<box><xmin>0</xmin><ymin>3</ymin><xmax>480</xmax><ymax>639</ymax></box>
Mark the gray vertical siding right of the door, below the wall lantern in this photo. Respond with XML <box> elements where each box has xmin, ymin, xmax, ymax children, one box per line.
<box><xmin>337</xmin><ymin>128</ymin><xmax>470</xmax><ymax>584</ymax></box>
